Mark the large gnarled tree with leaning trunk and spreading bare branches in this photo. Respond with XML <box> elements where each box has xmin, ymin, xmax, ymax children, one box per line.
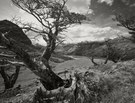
<box><xmin>0</xmin><ymin>0</ymin><xmax>86</xmax><ymax>100</ymax></box>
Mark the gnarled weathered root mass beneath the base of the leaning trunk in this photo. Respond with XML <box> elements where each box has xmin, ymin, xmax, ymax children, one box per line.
<box><xmin>33</xmin><ymin>73</ymin><xmax>89</xmax><ymax>103</ymax></box>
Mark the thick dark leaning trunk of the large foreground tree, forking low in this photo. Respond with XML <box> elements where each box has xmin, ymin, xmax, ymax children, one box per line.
<box><xmin>0</xmin><ymin>34</ymin><xmax>64</xmax><ymax>90</ymax></box>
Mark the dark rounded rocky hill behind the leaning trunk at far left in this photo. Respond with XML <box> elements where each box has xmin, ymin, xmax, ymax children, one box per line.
<box><xmin>0</xmin><ymin>20</ymin><xmax>32</xmax><ymax>45</ymax></box>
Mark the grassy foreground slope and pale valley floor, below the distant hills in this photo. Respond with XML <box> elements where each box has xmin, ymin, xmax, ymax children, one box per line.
<box><xmin>0</xmin><ymin>57</ymin><xmax>135</xmax><ymax>103</ymax></box>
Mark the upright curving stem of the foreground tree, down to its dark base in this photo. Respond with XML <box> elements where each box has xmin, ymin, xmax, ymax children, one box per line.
<box><xmin>40</xmin><ymin>31</ymin><xmax>64</xmax><ymax>90</ymax></box>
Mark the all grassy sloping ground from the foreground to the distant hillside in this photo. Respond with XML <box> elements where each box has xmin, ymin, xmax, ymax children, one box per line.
<box><xmin>0</xmin><ymin>19</ymin><xmax>135</xmax><ymax>103</ymax></box>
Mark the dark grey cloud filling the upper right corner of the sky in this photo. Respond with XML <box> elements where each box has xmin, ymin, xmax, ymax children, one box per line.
<box><xmin>90</xmin><ymin>0</ymin><xmax>135</xmax><ymax>26</ymax></box>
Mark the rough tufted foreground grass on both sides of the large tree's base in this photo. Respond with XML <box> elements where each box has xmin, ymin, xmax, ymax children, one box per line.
<box><xmin>0</xmin><ymin>58</ymin><xmax>135</xmax><ymax>103</ymax></box>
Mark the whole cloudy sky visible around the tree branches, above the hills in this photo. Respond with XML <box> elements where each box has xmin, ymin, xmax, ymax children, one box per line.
<box><xmin>0</xmin><ymin>0</ymin><xmax>135</xmax><ymax>44</ymax></box>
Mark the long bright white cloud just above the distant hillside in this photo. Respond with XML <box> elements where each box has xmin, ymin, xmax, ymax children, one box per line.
<box><xmin>66</xmin><ymin>24</ymin><xmax>128</xmax><ymax>43</ymax></box>
